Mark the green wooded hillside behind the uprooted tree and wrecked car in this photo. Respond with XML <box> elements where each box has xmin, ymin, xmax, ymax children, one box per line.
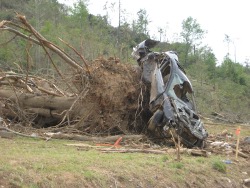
<box><xmin>0</xmin><ymin>0</ymin><xmax>250</xmax><ymax>122</ymax></box>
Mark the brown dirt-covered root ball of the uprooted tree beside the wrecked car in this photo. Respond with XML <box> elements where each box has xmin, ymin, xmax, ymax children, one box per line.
<box><xmin>72</xmin><ymin>58</ymin><xmax>144</xmax><ymax>134</ymax></box>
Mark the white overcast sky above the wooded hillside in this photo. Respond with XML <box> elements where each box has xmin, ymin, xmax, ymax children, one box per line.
<box><xmin>59</xmin><ymin>0</ymin><xmax>250</xmax><ymax>63</ymax></box>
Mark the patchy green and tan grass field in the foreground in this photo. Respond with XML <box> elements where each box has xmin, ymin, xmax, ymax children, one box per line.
<box><xmin>0</xmin><ymin>125</ymin><xmax>250</xmax><ymax>188</ymax></box>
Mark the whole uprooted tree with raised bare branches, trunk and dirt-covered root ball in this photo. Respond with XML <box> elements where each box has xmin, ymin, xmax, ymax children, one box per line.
<box><xmin>0</xmin><ymin>14</ymin><xmax>147</xmax><ymax>135</ymax></box>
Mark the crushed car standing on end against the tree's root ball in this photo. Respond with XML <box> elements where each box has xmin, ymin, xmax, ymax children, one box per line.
<box><xmin>132</xmin><ymin>39</ymin><xmax>208</xmax><ymax>147</ymax></box>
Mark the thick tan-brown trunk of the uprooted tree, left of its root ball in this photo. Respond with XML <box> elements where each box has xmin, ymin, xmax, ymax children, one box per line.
<box><xmin>0</xmin><ymin>88</ymin><xmax>90</xmax><ymax>125</ymax></box>
